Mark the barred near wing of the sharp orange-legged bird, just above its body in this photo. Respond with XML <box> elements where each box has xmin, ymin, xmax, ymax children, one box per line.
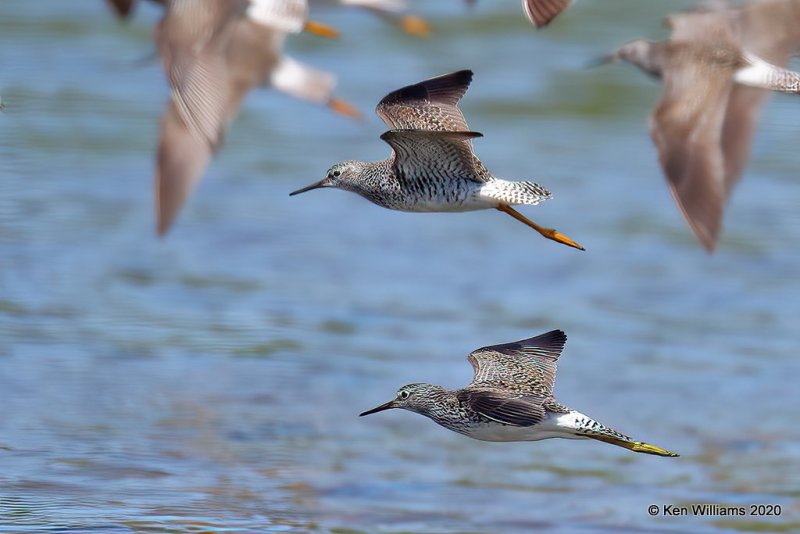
<box><xmin>381</xmin><ymin>130</ymin><xmax>483</xmax><ymax>189</ymax></box>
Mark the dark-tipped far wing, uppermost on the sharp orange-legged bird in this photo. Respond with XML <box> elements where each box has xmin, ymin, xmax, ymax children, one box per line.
<box><xmin>375</xmin><ymin>70</ymin><xmax>472</xmax><ymax>132</ymax></box>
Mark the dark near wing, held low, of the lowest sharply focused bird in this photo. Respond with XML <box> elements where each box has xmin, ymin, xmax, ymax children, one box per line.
<box><xmin>456</xmin><ymin>387</ymin><xmax>545</xmax><ymax>426</ymax></box>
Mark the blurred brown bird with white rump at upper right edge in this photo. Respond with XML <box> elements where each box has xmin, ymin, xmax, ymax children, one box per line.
<box><xmin>606</xmin><ymin>0</ymin><xmax>800</xmax><ymax>252</ymax></box>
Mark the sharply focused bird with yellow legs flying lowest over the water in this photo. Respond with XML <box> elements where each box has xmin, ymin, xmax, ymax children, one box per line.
<box><xmin>360</xmin><ymin>330</ymin><xmax>678</xmax><ymax>457</ymax></box>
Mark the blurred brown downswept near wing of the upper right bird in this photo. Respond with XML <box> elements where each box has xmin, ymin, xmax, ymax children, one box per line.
<box><xmin>650</xmin><ymin>49</ymin><xmax>733</xmax><ymax>251</ymax></box>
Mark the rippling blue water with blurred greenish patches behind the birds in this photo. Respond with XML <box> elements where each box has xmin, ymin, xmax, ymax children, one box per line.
<box><xmin>0</xmin><ymin>0</ymin><xmax>800</xmax><ymax>532</ymax></box>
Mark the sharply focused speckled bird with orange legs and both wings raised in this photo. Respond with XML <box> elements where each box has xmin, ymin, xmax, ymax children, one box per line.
<box><xmin>291</xmin><ymin>70</ymin><xmax>584</xmax><ymax>250</ymax></box>
